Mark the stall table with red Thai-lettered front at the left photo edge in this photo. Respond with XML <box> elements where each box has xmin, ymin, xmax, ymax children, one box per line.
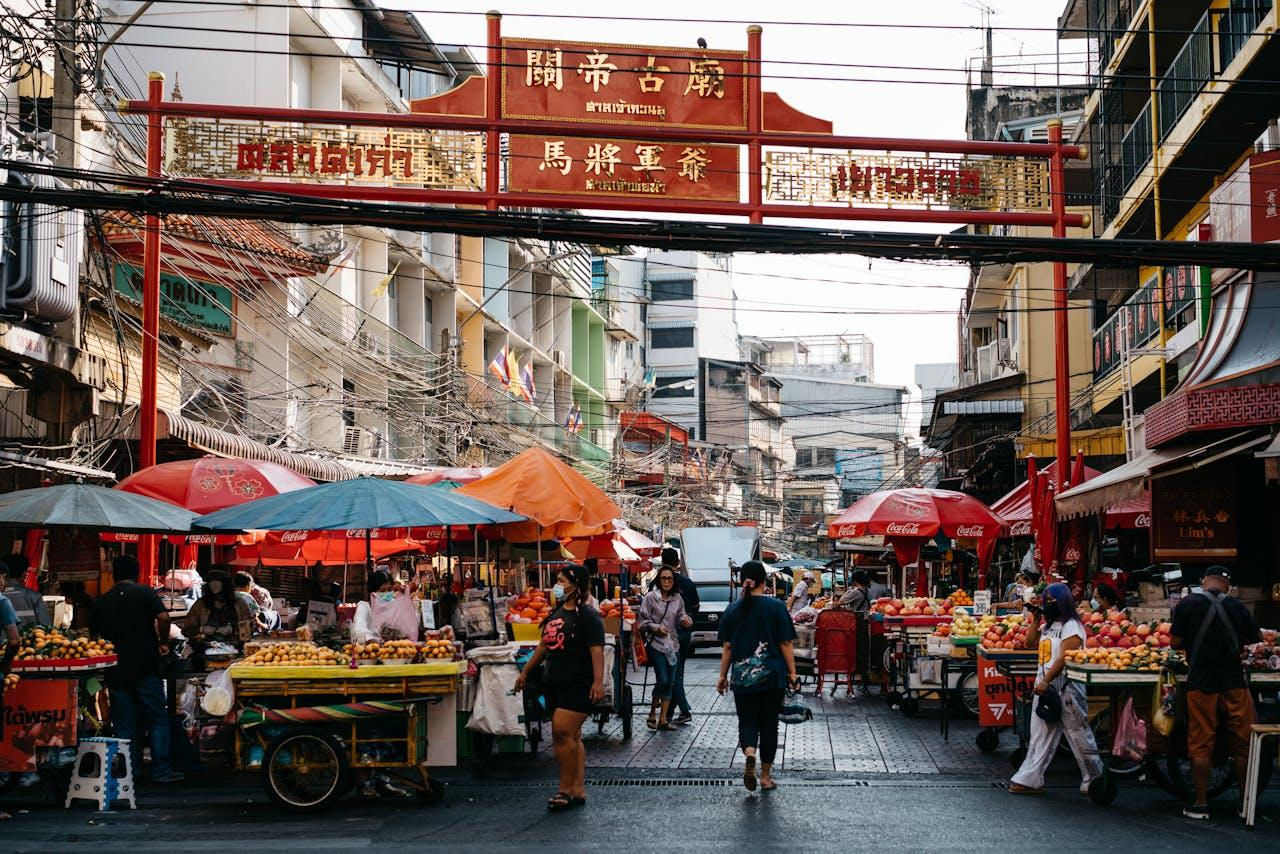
<box><xmin>0</xmin><ymin>653</ymin><xmax>116</xmax><ymax>803</ymax></box>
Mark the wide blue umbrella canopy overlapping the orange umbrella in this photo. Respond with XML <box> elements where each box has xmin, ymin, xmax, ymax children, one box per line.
<box><xmin>192</xmin><ymin>478</ymin><xmax>525</xmax><ymax>531</ymax></box>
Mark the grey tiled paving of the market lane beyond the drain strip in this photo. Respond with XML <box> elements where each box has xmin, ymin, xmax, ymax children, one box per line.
<box><xmin>547</xmin><ymin>656</ymin><xmax>1016</xmax><ymax>777</ymax></box>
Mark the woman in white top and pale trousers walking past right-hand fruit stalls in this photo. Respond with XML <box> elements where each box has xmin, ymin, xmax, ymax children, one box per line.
<box><xmin>1009</xmin><ymin>584</ymin><xmax>1102</xmax><ymax>795</ymax></box>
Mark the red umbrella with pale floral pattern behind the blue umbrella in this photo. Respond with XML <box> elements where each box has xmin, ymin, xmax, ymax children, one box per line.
<box><xmin>116</xmin><ymin>457</ymin><xmax>316</xmax><ymax>513</ymax></box>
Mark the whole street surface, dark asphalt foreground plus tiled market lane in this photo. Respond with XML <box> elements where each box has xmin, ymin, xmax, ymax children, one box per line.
<box><xmin>0</xmin><ymin>656</ymin><xmax>1280</xmax><ymax>853</ymax></box>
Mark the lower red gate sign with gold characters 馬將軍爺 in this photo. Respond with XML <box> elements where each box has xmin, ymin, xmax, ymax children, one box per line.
<box><xmin>507</xmin><ymin>134</ymin><xmax>741</xmax><ymax>202</ymax></box>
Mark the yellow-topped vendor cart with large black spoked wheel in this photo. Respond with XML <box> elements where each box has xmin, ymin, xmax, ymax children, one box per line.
<box><xmin>229</xmin><ymin>659</ymin><xmax>466</xmax><ymax>812</ymax></box>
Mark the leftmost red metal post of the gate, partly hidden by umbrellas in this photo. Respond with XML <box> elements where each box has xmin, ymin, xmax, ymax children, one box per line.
<box><xmin>138</xmin><ymin>72</ymin><xmax>164</xmax><ymax>584</ymax></box>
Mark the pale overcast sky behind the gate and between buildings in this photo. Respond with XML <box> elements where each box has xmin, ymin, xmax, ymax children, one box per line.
<box><xmin>394</xmin><ymin>0</ymin><xmax>1068</xmax><ymax>384</ymax></box>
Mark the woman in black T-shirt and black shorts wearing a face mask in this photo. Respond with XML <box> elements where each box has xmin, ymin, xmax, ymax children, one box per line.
<box><xmin>516</xmin><ymin>566</ymin><xmax>604</xmax><ymax>812</ymax></box>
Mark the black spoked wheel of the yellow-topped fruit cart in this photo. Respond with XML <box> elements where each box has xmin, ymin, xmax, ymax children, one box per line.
<box><xmin>262</xmin><ymin>726</ymin><xmax>351</xmax><ymax>812</ymax></box>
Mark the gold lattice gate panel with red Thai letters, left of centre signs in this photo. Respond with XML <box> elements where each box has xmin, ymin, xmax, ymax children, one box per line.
<box><xmin>165</xmin><ymin>119</ymin><xmax>484</xmax><ymax>189</ymax></box>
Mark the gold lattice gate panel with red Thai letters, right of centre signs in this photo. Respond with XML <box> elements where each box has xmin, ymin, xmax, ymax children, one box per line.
<box><xmin>763</xmin><ymin>150</ymin><xmax>1051</xmax><ymax>211</ymax></box>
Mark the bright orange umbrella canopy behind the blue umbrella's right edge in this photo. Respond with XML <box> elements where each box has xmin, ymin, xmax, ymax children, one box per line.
<box><xmin>457</xmin><ymin>448</ymin><xmax>622</xmax><ymax>543</ymax></box>
